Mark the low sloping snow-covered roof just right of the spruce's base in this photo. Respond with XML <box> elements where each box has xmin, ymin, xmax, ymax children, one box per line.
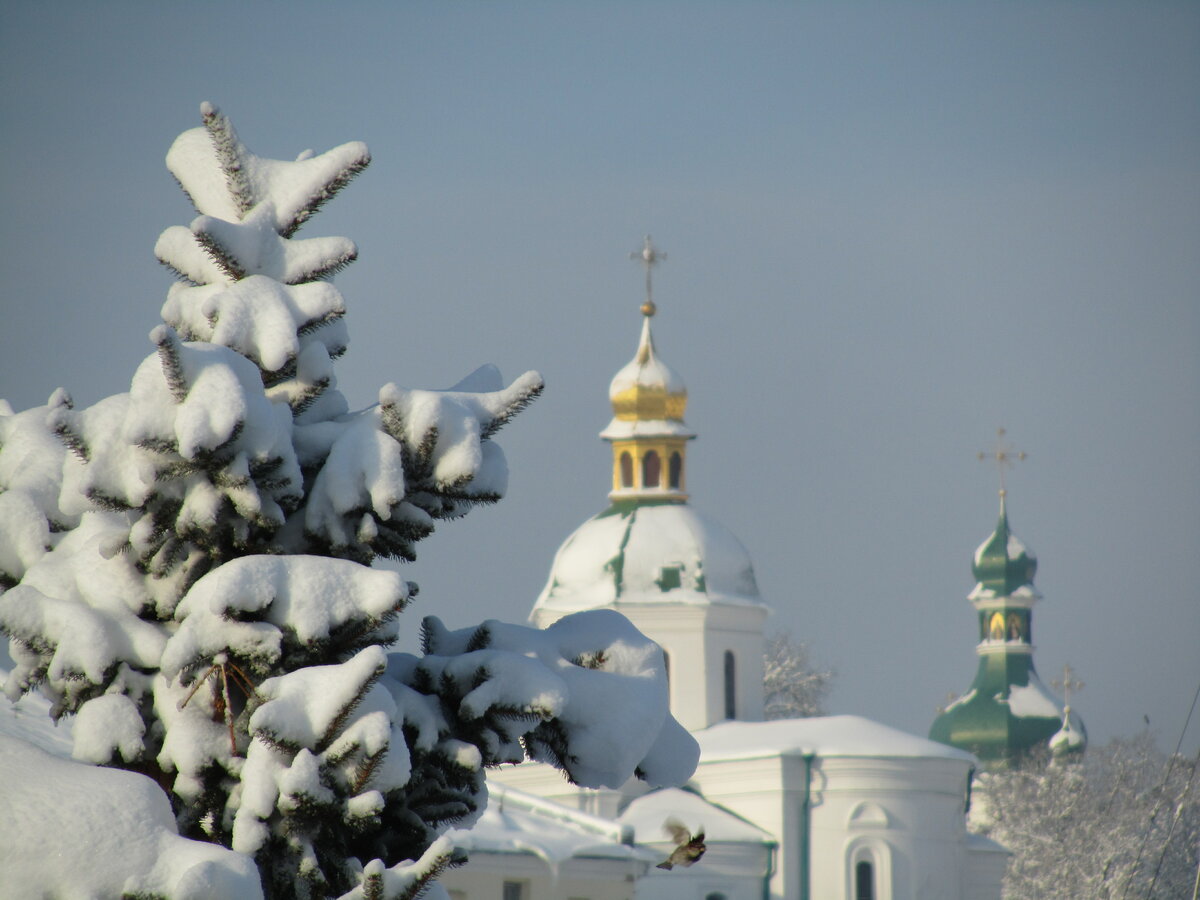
<box><xmin>450</xmin><ymin>780</ymin><xmax>658</xmax><ymax>866</ymax></box>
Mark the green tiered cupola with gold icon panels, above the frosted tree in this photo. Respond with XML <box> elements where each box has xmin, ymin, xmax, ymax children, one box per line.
<box><xmin>929</xmin><ymin>444</ymin><xmax>1087</xmax><ymax>768</ymax></box>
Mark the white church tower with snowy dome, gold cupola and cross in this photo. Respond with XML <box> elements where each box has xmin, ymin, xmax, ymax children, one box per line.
<box><xmin>530</xmin><ymin>236</ymin><xmax>769</xmax><ymax>731</ymax></box>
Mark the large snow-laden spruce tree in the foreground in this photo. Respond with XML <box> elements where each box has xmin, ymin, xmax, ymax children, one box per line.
<box><xmin>0</xmin><ymin>104</ymin><xmax>697</xmax><ymax>898</ymax></box>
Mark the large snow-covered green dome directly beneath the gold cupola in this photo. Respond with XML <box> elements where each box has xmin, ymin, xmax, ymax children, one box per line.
<box><xmin>534</xmin><ymin>503</ymin><xmax>762</xmax><ymax>612</ymax></box>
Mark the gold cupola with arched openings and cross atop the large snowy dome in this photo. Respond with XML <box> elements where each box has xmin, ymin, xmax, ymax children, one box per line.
<box><xmin>600</xmin><ymin>235</ymin><xmax>696</xmax><ymax>503</ymax></box>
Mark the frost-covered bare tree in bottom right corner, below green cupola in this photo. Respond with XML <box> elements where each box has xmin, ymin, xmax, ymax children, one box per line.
<box><xmin>972</xmin><ymin>733</ymin><xmax>1200</xmax><ymax>900</ymax></box>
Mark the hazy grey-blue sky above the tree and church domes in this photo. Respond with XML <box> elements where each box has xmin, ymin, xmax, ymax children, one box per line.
<box><xmin>0</xmin><ymin>1</ymin><xmax>1200</xmax><ymax>750</ymax></box>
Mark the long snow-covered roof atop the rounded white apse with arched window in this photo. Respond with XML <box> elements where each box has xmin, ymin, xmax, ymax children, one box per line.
<box><xmin>694</xmin><ymin>715</ymin><xmax>974</xmax><ymax>764</ymax></box>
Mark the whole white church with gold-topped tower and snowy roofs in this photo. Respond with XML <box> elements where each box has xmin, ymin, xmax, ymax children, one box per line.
<box><xmin>442</xmin><ymin>239</ymin><xmax>1008</xmax><ymax>900</ymax></box>
